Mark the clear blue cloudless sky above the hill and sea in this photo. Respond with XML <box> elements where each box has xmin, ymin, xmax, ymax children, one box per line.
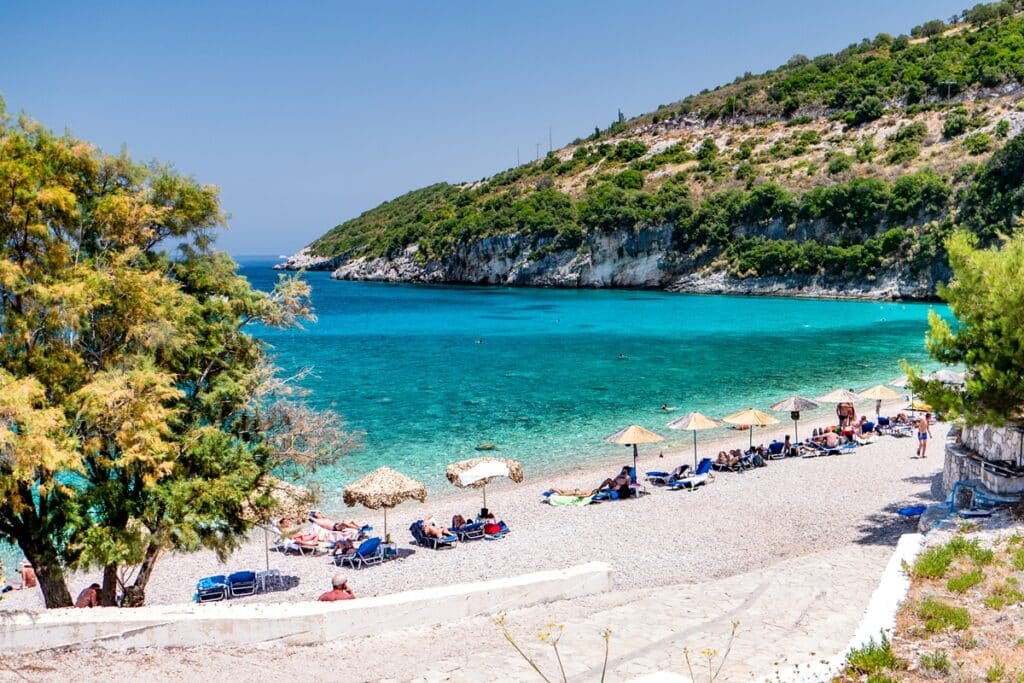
<box><xmin>0</xmin><ymin>0</ymin><xmax>973</xmax><ymax>254</ymax></box>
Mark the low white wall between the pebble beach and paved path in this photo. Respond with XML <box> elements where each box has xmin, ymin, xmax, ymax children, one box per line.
<box><xmin>0</xmin><ymin>562</ymin><xmax>611</xmax><ymax>652</ymax></box>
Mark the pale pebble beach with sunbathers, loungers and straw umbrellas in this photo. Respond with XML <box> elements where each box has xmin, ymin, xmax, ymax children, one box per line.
<box><xmin>0</xmin><ymin>401</ymin><xmax>946</xmax><ymax>610</ymax></box>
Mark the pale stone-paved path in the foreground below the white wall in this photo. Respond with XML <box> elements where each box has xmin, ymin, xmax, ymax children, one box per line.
<box><xmin>0</xmin><ymin>545</ymin><xmax>892</xmax><ymax>683</ymax></box>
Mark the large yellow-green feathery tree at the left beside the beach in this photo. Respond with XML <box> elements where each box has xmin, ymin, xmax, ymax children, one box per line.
<box><xmin>0</xmin><ymin>113</ymin><xmax>349</xmax><ymax>607</ymax></box>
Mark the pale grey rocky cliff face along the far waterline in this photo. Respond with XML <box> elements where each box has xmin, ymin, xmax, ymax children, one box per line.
<box><xmin>275</xmin><ymin>225</ymin><xmax>948</xmax><ymax>299</ymax></box>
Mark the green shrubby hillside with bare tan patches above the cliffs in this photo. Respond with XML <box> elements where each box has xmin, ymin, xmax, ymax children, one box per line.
<box><xmin>308</xmin><ymin>2</ymin><xmax>1024</xmax><ymax>286</ymax></box>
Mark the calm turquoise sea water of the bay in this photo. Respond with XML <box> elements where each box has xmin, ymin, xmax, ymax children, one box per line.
<box><xmin>0</xmin><ymin>259</ymin><xmax>948</xmax><ymax>578</ymax></box>
